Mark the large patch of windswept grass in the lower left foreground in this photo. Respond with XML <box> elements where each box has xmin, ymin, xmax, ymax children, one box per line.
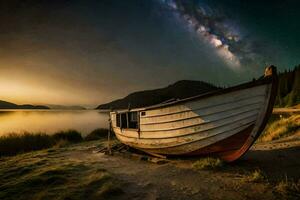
<box><xmin>0</xmin><ymin>149</ymin><xmax>123</xmax><ymax>200</ymax></box>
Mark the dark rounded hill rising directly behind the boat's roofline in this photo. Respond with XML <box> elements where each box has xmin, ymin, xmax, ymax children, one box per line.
<box><xmin>96</xmin><ymin>80</ymin><xmax>220</xmax><ymax>109</ymax></box>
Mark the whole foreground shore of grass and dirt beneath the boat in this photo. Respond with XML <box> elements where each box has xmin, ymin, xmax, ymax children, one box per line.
<box><xmin>0</xmin><ymin>134</ymin><xmax>300</xmax><ymax>200</ymax></box>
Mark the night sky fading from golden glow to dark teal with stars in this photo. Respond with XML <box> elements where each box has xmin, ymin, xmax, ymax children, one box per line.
<box><xmin>0</xmin><ymin>0</ymin><xmax>300</xmax><ymax>107</ymax></box>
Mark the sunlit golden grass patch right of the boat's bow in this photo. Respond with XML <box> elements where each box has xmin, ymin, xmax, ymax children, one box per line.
<box><xmin>260</xmin><ymin>115</ymin><xmax>300</xmax><ymax>142</ymax></box>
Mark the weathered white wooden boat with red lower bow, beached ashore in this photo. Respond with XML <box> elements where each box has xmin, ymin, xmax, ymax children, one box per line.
<box><xmin>110</xmin><ymin>66</ymin><xmax>278</xmax><ymax>162</ymax></box>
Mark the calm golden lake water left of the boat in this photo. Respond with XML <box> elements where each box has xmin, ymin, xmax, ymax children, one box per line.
<box><xmin>0</xmin><ymin>110</ymin><xmax>108</xmax><ymax>136</ymax></box>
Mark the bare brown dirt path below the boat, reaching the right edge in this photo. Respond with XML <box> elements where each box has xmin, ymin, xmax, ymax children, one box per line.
<box><xmin>64</xmin><ymin>138</ymin><xmax>300</xmax><ymax>199</ymax></box>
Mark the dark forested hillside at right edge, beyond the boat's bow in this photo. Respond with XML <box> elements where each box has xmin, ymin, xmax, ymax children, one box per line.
<box><xmin>275</xmin><ymin>65</ymin><xmax>300</xmax><ymax>107</ymax></box>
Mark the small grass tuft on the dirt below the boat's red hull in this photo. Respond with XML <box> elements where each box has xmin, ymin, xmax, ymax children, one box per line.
<box><xmin>193</xmin><ymin>157</ymin><xmax>224</xmax><ymax>170</ymax></box>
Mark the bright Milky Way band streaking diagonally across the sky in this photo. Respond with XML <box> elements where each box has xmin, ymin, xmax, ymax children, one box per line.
<box><xmin>161</xmin><ymin>0</ymin><xmax>259</xmax><ymax>70</ymax></box>
